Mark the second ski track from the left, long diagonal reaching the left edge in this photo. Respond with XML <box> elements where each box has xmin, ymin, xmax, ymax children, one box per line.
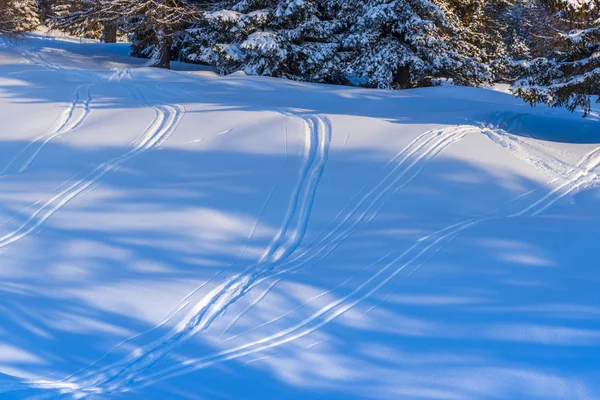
<box><xmin>0</xmin><ymin>84</ymin><xmax>183</xmax><ymax>250</ymax></box>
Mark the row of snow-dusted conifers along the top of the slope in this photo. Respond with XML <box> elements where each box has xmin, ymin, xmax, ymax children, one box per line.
<box><xmin>0</xmin><ymin>0</ymin><xmax>600</xmax><ymax>113</ymax></box>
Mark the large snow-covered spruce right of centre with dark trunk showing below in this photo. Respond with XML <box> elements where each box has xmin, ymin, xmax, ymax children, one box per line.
<box><xmin>334</xmin><ymin>0</ymin><xmax>492</xmax><ymax>88</ymax></box>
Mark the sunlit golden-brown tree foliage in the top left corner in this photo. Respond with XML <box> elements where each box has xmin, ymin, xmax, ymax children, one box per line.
<box><xmin>0</xmin><ymin>0</ymin><xmax>40</xmax><ymax>34</ymax></box>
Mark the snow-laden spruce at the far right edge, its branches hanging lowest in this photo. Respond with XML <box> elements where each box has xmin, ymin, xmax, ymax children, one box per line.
<box><xmin>513</xmin><ymin>0</ymin><xmax>600</xmax><ymax>114</ymax></box>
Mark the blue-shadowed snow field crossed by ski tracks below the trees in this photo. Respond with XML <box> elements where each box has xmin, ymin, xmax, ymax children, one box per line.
<box><xmin>0</xmin><ymin>36</ymin><xmax>600</xmax><ymax>400</ymax></box>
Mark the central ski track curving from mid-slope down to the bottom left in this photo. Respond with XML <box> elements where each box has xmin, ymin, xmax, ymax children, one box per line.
<box><xmin>45</xmin><ymin>115</ymin><xmax>331</xmax><ymax>393</ymax></box>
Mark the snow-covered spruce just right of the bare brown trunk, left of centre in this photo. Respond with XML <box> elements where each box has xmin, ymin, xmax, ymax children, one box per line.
<box><xmin>182</xmin><ymin>0</ymin><xmax>344</xmax><ymax>82</ymax></box>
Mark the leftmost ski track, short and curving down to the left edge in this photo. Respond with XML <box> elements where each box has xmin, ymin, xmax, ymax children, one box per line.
<box><xmin>0</xmin><ymin>84</ymin><xmax>92</xmax><ymax>176</ymax></box>
